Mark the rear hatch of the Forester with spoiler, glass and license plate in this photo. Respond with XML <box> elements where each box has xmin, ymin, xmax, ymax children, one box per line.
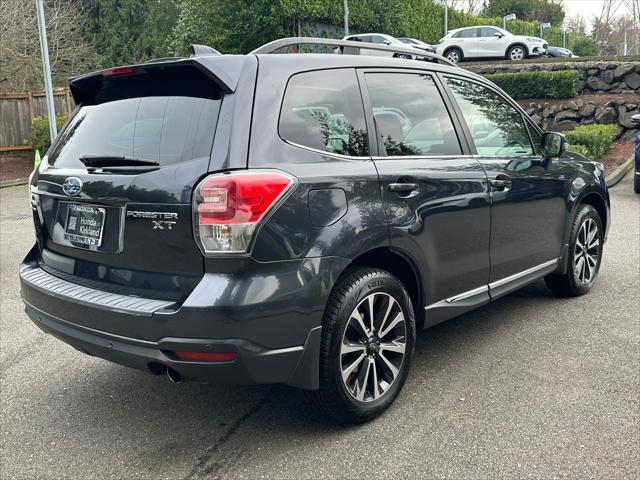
<box><xmin>31</xmin><ymin>60</ymin><xmax>228</xmax><ymax>300</ymax></box>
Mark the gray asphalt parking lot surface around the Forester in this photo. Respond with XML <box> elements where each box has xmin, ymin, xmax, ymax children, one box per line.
<box><xmin>0</xmin><ymin>175</ymin><xmax>640</xmax><ymax>479</ymax></box>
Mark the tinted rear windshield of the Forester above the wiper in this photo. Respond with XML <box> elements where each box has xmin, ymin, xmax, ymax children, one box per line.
<box><xmin>49</xmin><ymin>96</ymin><xmax>221</xmax><ymax>167</ymax></box>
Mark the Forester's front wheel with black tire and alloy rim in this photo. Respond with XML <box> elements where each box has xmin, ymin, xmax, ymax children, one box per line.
<box><xmin>544</xmin><ymin>205</ymin><xmax>604</xmax><ymax>297</ymax></box>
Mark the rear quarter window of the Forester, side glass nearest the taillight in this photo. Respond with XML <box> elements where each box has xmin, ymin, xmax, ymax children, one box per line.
<box><xmin>279</xmin><ymin>69</ymin><xmax>369</xmax><ymax>156</ymax></box>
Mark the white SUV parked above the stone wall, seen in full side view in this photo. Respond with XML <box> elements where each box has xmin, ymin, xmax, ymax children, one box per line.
<box><xmin>436</xmin><ymin>25</ymin><xmax>547</xmax><ymax>63</ymax></box>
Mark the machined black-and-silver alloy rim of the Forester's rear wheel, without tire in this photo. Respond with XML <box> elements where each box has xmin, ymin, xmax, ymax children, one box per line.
<box><xmin>340</xmin><ymin>292</ymin><xmax>407</xmax><ymax>402</ymax></box>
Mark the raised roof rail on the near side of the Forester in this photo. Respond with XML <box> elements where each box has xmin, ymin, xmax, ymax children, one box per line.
<box><xmin>251</xmin><ymin>37</ymin><xmax>457</xmax><ymax>67</ymax></box>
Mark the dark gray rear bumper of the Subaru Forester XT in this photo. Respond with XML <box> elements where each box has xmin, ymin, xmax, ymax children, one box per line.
<box><xmin>20</xmin><ymin>248</ymin><xmax>347</xmax><ymax>389</ymax></box>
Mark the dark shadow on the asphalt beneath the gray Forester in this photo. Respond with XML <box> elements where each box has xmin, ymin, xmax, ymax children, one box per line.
<box><xmin>38</xmin><ymin>282</ymin><xmax>558</xmax><ymax>477</ymax></box>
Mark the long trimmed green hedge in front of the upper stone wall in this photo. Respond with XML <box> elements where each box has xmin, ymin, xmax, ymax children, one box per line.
<box><xmin>485</xmin><ymin>70</ymin><xmax>578</xmax><ymax>100</ymax></box>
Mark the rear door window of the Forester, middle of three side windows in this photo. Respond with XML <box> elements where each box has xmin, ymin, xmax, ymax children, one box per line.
<box><xmin>366</xmin><ymin>73</ymin><xmax>461</xmax><ymax>155</ymax></box>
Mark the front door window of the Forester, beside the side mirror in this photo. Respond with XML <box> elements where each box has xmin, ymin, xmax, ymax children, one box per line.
<box><xmin>447</xmin><ymin>78</ymin><xmax>534</xmax><ymax>157</ymax></box>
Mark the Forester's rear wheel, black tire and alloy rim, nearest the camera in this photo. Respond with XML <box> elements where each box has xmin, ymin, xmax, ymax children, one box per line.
<box><xmin>311</xmin><ymin>268</ymin><xmax>416</xmax><ymax>424</ymax></box>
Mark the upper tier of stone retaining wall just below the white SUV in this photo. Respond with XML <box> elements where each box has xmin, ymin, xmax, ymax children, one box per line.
<box><xmin>460</xmin><ymin>60</ymin><xmax>640</xmax><ymax>94</ymax></box>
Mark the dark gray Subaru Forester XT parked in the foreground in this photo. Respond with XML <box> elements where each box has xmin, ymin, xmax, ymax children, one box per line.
<box><xmin>20</xmin><ymin>38</ymin><xmax>609</xmax><ymax>422</ymax></box>
